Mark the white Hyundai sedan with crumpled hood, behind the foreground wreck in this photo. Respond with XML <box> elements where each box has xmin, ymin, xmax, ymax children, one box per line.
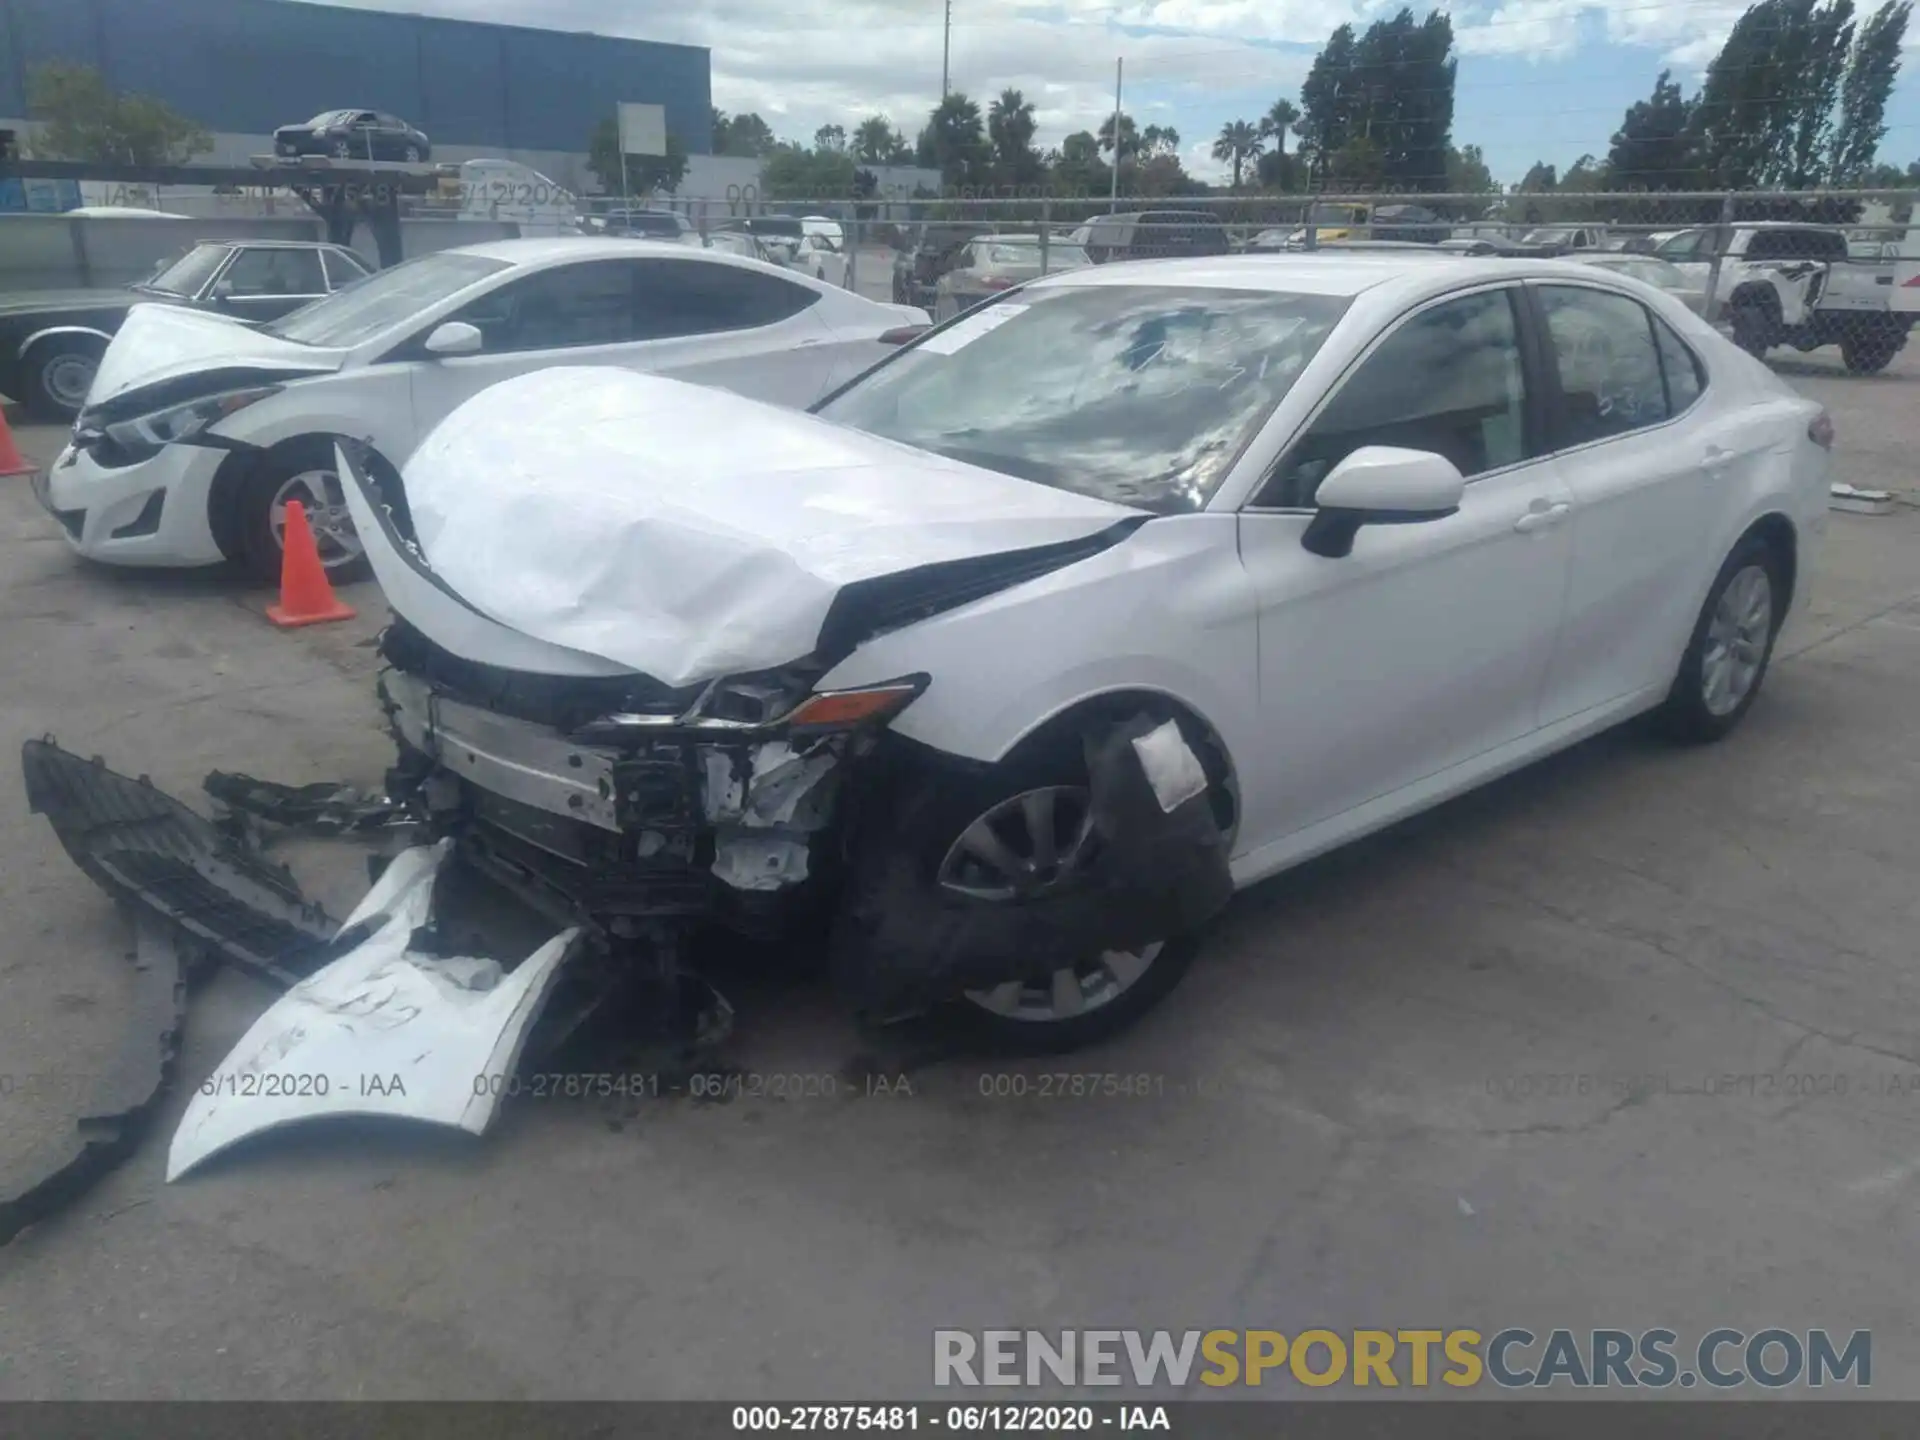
<box><xmin>38</xmin><ymin>236</ymin><xmax>927</xmax><ymax>580</ymax></box>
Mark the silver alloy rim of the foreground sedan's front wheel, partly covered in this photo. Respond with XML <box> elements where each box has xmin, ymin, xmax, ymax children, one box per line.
<box><xmin>939</xmin><ymin>785</ymin><xmax>1165</xmax><ymax>1023</ymax></box>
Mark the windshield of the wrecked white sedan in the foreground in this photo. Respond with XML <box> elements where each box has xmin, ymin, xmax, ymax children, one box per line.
<box><xmin>818</xmin><ymin>284</ymin><xmax>1348</xmax><ymax>515</ymax></box>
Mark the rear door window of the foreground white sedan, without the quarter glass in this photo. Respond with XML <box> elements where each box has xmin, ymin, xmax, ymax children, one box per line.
<box><xmin>1538</xmin><ymin>284</ymin><xmax>1668</xmax><ymax>445</ymax></box>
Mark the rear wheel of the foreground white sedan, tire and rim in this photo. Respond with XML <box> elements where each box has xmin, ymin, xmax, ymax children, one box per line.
<box><xmin>1655</xmin><ymin>536</ymin><xmax>1788</xmax><ymax>745</ymax></box>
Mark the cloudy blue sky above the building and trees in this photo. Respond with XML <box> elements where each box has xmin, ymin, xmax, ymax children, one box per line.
<box><xmin>307</xmin><ymin>0</ymin><xmax>1920</xmax><ymax>180</ymax></box>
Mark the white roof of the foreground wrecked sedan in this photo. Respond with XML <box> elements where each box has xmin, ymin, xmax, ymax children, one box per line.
<box><xmin>1031</xmin><ymin>246</ymin><xmax>1643</xmax><ymax>298</ymax></box>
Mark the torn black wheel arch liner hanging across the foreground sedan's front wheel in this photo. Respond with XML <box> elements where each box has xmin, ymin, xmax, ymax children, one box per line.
<box><xmin>831</xmin><ymin>712</ymin><xmax>1233</xmax><ymax>1020</ymax></box>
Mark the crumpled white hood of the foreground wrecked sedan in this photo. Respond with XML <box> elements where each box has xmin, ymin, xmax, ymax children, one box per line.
<box><xmin>388</xmin><ymin>367</ymin><xmax>1146</xmax><ymax>685</ymax></box>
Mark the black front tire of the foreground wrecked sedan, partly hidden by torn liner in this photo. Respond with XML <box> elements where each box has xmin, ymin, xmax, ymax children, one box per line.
<box><xmin>833</xmin><ymin>737</ymin><xmax>1198</xmax><ymax>1054</ymax></box>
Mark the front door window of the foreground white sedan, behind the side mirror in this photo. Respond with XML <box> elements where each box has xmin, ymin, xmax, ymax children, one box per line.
<box><xmin>1258</xmin><ymin>290</ymin><xmax>1528</xmax><ymax>509</ymax></box>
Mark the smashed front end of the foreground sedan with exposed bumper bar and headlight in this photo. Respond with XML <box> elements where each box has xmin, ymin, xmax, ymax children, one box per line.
<box><xmin>378</xmin><ymin>620</ymin><xmax>927</xmax><ymax>937</ymax></box>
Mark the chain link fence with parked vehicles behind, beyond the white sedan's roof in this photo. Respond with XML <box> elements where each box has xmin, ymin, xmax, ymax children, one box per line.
<box><xmin>721</xmin><ymin>190</ymin><xmax>1920</xmax><ymax>372</ymax></box>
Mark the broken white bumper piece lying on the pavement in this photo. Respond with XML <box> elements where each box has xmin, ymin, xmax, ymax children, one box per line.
<box><xmin>167</xmin><ymin>841</ymin><xmax>580</xmax><ymax>1181</ymax></box>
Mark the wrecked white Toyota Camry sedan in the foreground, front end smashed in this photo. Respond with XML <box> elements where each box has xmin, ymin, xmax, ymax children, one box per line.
<box><xmin>340</xmin><ymin>253</ymin><xmax>1834</xmax><ymax>1050</ymax></box>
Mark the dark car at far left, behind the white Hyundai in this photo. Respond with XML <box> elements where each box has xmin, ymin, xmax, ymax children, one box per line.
<box><xmin>0</xmin><ymin>240</ymin><xmax>372</xmax><ymax>420</ymax></box>
